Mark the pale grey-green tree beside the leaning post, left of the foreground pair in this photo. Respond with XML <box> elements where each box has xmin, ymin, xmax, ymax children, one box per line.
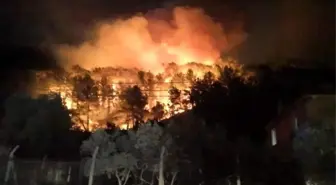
<box><xmin>81</xmin><ymin>129</ymin><xmax>137</xmax><ymax>185</ymax></box>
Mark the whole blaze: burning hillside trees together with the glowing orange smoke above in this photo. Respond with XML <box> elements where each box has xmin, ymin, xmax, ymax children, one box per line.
<box><xmin>33</xmin><ymin>7</ymin><xmax>246</xmax><ymax>130</ymax></box>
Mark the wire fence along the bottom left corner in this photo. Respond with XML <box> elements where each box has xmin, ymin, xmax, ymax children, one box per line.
<box><xmin>0</xmin><ymin>159</ymin><xmax>86</xmax><ymax>185</ymax></box>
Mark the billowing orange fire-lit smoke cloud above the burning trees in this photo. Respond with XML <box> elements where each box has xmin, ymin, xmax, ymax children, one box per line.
<box><xmin>56</xmin><ymin>7</ymin><xmax>245</xmax><ymax>72</ymax></box>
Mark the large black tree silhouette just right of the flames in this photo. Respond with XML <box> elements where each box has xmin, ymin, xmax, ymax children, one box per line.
<box><xmin>190</xmin><ymin>67</ymin><xmax>279</xmax><ymax>143</ymax></box>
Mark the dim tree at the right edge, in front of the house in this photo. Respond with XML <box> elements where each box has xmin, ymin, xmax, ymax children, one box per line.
<box><xmin>293</xmin><ymin>96</ymin><xmax>336</xmax><ymax>184</ymax></box>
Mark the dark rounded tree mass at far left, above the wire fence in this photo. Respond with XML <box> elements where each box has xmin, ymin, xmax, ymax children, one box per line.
<box><xmin>1</xmin><ymin>94</ymin><xmax>89</xmax><ymax>159</ymax></box>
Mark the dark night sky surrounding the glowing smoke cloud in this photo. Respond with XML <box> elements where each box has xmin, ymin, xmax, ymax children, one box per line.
<box><xmin>0</xmin><ymin>0</ymin><xmax>336</xmax><ymax>68</ymax></box>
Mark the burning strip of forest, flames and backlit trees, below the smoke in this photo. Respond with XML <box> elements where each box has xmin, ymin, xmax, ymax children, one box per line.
<box><xmin>36</xmin><ymin>60</ymin><xmax>242</xmax><ymax>131</ymax></box>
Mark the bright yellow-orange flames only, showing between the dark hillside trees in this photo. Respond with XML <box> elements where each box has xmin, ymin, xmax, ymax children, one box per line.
<box><xmin>37</xmin><ymin>63</ymin><xmax>239</xmax><ymax>131</ymax></box>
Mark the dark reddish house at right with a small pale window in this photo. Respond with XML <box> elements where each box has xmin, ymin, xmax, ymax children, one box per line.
<box><xmin>266</xmin><ymin>94</ymin><xmax>336</xmax><ymax>160</ymax></box>
